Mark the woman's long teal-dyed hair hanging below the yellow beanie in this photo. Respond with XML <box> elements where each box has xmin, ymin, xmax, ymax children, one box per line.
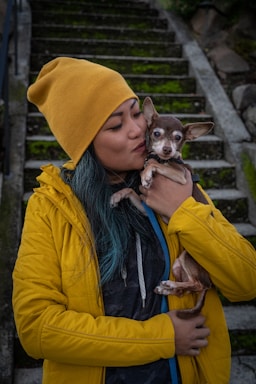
<box><xmin>62</xmin><ymin>146</ymin><xmax>154</xmax><ymax>285</ymax></box>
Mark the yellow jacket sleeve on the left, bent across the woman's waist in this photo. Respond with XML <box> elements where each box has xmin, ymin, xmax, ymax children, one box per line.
<box><xmin>13</xmin><ymin>195</ymin><xmax>175</xmax><ymax>366</ymax></box>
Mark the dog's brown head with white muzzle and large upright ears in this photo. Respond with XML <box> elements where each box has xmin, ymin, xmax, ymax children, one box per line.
<box><xmin>142</xmin><ymin>97</ymin><xmax>214</xmax><ymax>161</ymax></box>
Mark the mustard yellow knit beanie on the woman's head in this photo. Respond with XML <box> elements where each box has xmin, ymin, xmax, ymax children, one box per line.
<box><xmin>28</xmin><ymin>57</ymin><xmax>137</xmax><ymax>164</ymax></box>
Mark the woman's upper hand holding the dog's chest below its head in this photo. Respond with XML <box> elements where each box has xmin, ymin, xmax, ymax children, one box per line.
<box><xmin>140</xmin><ymin>169</ymin><xmax>193</xmax><ymax>220</ymax></box>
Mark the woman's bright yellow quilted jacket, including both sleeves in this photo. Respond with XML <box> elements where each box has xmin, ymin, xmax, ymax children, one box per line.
<box><xmin>13</xmin><ymin>164</ymin><xmax>256</xmax><ymax>384</ymax></box>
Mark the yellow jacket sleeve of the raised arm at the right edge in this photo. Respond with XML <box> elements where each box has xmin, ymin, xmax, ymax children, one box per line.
<box><xmin>168</xmin><ymin>189</ymin><xmax>256</xmax><ymax>301</ymax></box>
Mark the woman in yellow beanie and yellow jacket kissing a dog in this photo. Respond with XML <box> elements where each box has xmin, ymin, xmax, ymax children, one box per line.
<box><xmin>13</xmin><ymin>58</ymin><xmax>256</xmax><ymax>384</ymax></box>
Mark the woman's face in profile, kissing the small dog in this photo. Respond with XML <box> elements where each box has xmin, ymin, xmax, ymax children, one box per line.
<box><xmin>93</xmin><ymin>99</ymin><xmax>146</xmax><ymax>176</ymax></box>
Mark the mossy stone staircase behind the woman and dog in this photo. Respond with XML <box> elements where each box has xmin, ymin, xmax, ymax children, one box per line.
<box><xmin>14</xmin><ymin>0</ymin><xmax>256</xmax><ymax>384</ymax></box>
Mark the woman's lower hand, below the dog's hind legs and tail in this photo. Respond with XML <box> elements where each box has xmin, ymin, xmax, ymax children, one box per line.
<box><xmin>167</xmin><ymin>311</ymin><xmax>210</xmax><ymax>356</ymax></box>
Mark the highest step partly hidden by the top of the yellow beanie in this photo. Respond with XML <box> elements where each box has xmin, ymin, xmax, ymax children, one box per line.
<box><xmin>30</xmin><ymin>52</ymin><xmax>188</xmax><ymax>76</ymax></box>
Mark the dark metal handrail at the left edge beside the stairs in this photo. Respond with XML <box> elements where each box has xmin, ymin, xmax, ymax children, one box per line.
<box><xmin>0</xmin><ymin>0</ymin><xmax>21</xmax><ymax>176</ymax></box>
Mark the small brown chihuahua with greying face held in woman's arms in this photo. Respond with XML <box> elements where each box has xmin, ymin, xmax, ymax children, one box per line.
<box><xmin>110</xmin><ymin>97</ymin><xmax>214</xmax><ymax>319</ymax></box>
